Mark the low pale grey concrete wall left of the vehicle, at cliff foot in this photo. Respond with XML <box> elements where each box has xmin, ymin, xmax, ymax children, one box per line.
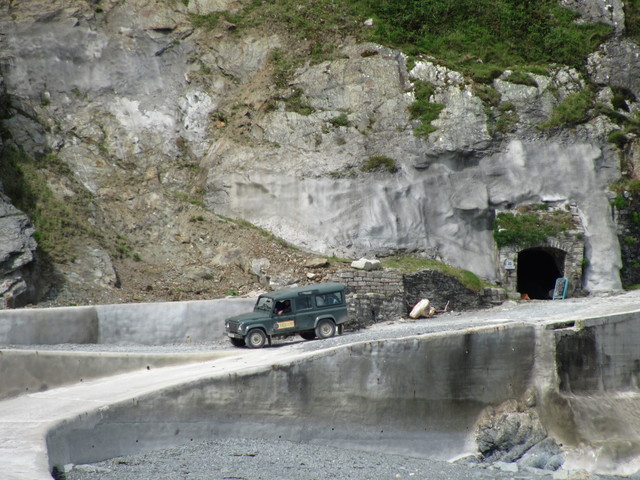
<box><xmin>0</xmin><ymin>298</ymin><xmax>255</xmax><ymax>345</ymax></box>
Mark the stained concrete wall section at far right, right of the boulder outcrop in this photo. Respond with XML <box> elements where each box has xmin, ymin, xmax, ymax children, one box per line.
<box><xmin>540</xmin><ymin>312</ymin><xmax>640</xmax><ymax>475</ymax></box>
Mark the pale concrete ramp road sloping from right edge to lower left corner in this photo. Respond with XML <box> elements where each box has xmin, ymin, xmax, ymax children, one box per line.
<box><xmin>0</xmin><ymin>292</ymin><xmax>640</xmax><ymax>480</ymax></box>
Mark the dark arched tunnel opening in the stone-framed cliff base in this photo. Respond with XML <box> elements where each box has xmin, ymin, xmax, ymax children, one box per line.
<box><xmin>517</xmin><ymin>248</ymin><xmax>566</xmax><ymax>300</ymax></box>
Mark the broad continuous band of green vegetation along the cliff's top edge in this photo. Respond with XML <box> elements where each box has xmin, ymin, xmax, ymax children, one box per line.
<box><xmin>192</xmin><ymin>0</ymin><xmax>616</xmax><ymax>73</ymax></box>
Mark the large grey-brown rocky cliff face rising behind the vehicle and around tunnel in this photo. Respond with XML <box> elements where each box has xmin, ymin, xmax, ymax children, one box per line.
<box><xmin>0</xmin><ymin>0</ymin><xmax>640</xmax><ymax>301</ymax></box>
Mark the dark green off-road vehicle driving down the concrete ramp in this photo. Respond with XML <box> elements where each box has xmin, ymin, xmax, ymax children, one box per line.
<box><xmin>225</xmin><ymin>283</ymin><xmax>347</xmax><ymax>348</ymax></box>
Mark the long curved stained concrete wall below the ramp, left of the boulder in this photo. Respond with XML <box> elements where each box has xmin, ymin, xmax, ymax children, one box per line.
<box><xmin>48</xmin><ymin>324</ymin><xmax>535</xmax><ymax>466</ymax></box>
